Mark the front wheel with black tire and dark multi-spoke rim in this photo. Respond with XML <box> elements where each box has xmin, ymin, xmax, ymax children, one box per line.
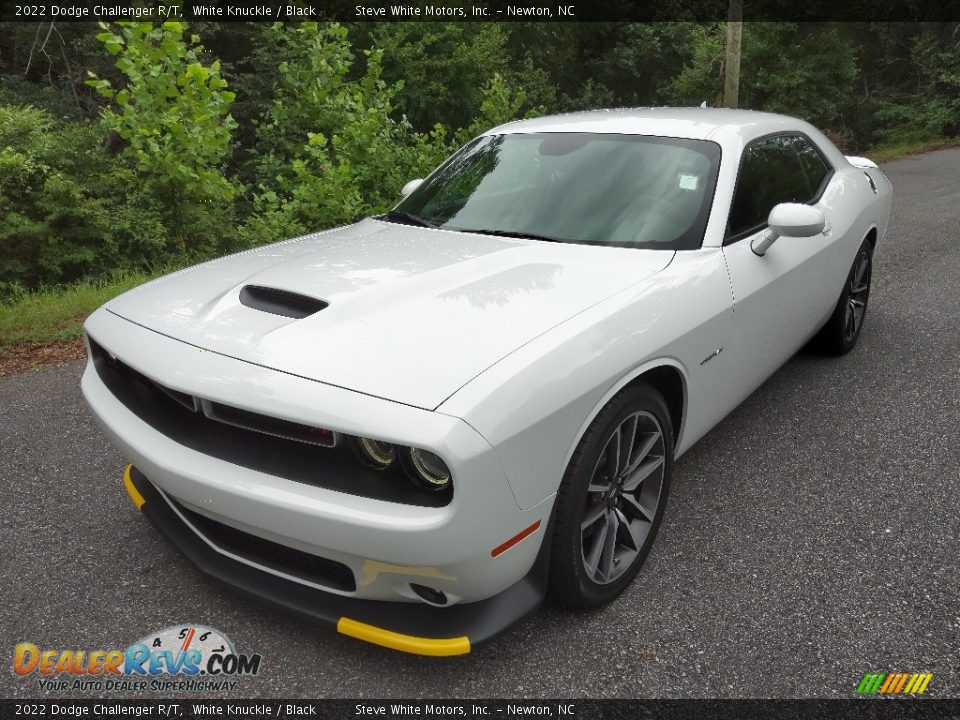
<box><xmin>549</xmin><ymin>384</ymin><xmax>673</xmax><ymax>608</ymax></box>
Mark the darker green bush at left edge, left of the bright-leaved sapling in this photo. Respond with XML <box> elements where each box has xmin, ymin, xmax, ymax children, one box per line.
<box><xmin>0</xmin><ymin>105</ymin><xmax>164</xmax><ymax>291</ymax></box>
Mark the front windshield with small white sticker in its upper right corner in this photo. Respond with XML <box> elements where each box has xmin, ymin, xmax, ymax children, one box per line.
<box><xmin>385</xmin><ymin>133</ymin><xmax>720</xmax><ymax>250</ymax></box>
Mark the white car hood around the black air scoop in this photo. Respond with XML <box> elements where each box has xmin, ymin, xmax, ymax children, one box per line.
<box><xmin>107</xmin><ymin>219</ymin><xmax>674</xmax><ymax>409</ymax></box>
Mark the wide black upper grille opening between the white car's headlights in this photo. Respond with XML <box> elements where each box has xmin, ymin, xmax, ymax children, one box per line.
<box><xmin>88</xmin><ymin>337</ymin><xmax>453</xmax><ymax>507</ymax></box>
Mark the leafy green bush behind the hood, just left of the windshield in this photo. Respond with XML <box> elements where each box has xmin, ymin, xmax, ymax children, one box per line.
<box><xmin>241</xmin><ymin>23</ymin><xmax>450</xmax><ymax>245</ymax></box>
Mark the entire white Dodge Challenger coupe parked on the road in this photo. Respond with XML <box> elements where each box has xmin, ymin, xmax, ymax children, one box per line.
<box><xmin>82</xmin><ymin>108</ymin><xmax>891</xmax><ymax>655</ymax></box>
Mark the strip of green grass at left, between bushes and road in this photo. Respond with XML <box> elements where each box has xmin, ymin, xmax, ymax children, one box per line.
<box><xmin>0</xmin><ymin>273</ymin><xmax>151</xmax><ymax>356</ymax></box>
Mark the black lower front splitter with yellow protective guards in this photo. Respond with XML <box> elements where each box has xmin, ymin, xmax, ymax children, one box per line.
<box><xmin>124</xmin><ymin>467</ymin><xmax>548</xmax><ymax>656</ymax></box>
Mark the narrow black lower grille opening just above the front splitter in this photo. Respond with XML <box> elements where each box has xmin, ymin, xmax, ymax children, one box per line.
<box><xmin>169</xmin><ymin>498</ymin><xmax>357</xmax><ymax>592</ymax></box>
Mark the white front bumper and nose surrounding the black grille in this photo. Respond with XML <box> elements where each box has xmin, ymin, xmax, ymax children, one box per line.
<box><xmin>81</xmin><ymin>309</ymin><xmax>553</xmax><ymax>646</ymax></box>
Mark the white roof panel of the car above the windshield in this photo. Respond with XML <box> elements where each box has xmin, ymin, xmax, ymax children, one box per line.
<box><xmin>484</xmin><ymin>107</ymin><xmax>812</xmax><ymax>142</ymax></box>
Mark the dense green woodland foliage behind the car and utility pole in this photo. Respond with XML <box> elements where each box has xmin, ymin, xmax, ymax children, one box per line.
<box><xmin>0</xmin><ymin>22</ymin><xmax>960</xmax><ymax>294</ymax></box>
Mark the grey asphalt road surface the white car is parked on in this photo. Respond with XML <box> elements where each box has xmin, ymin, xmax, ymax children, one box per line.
<box><xmin>0</xmin><ymin>150</ymin><xmax>960</xmax><ymax>698</ymax></box>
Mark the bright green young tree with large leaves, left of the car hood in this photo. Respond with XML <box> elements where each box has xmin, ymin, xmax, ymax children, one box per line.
<box><xmin>87</xmin><ymin>22</ymin><xmax>236</xmax><ymax>255</ymax></box>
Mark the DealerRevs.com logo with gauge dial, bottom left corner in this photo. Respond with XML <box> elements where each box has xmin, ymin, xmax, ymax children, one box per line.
<box><xmin>13</xmin><ymin>623</ymin><xmax>261</xmax><ymax>693</ymax></box>
